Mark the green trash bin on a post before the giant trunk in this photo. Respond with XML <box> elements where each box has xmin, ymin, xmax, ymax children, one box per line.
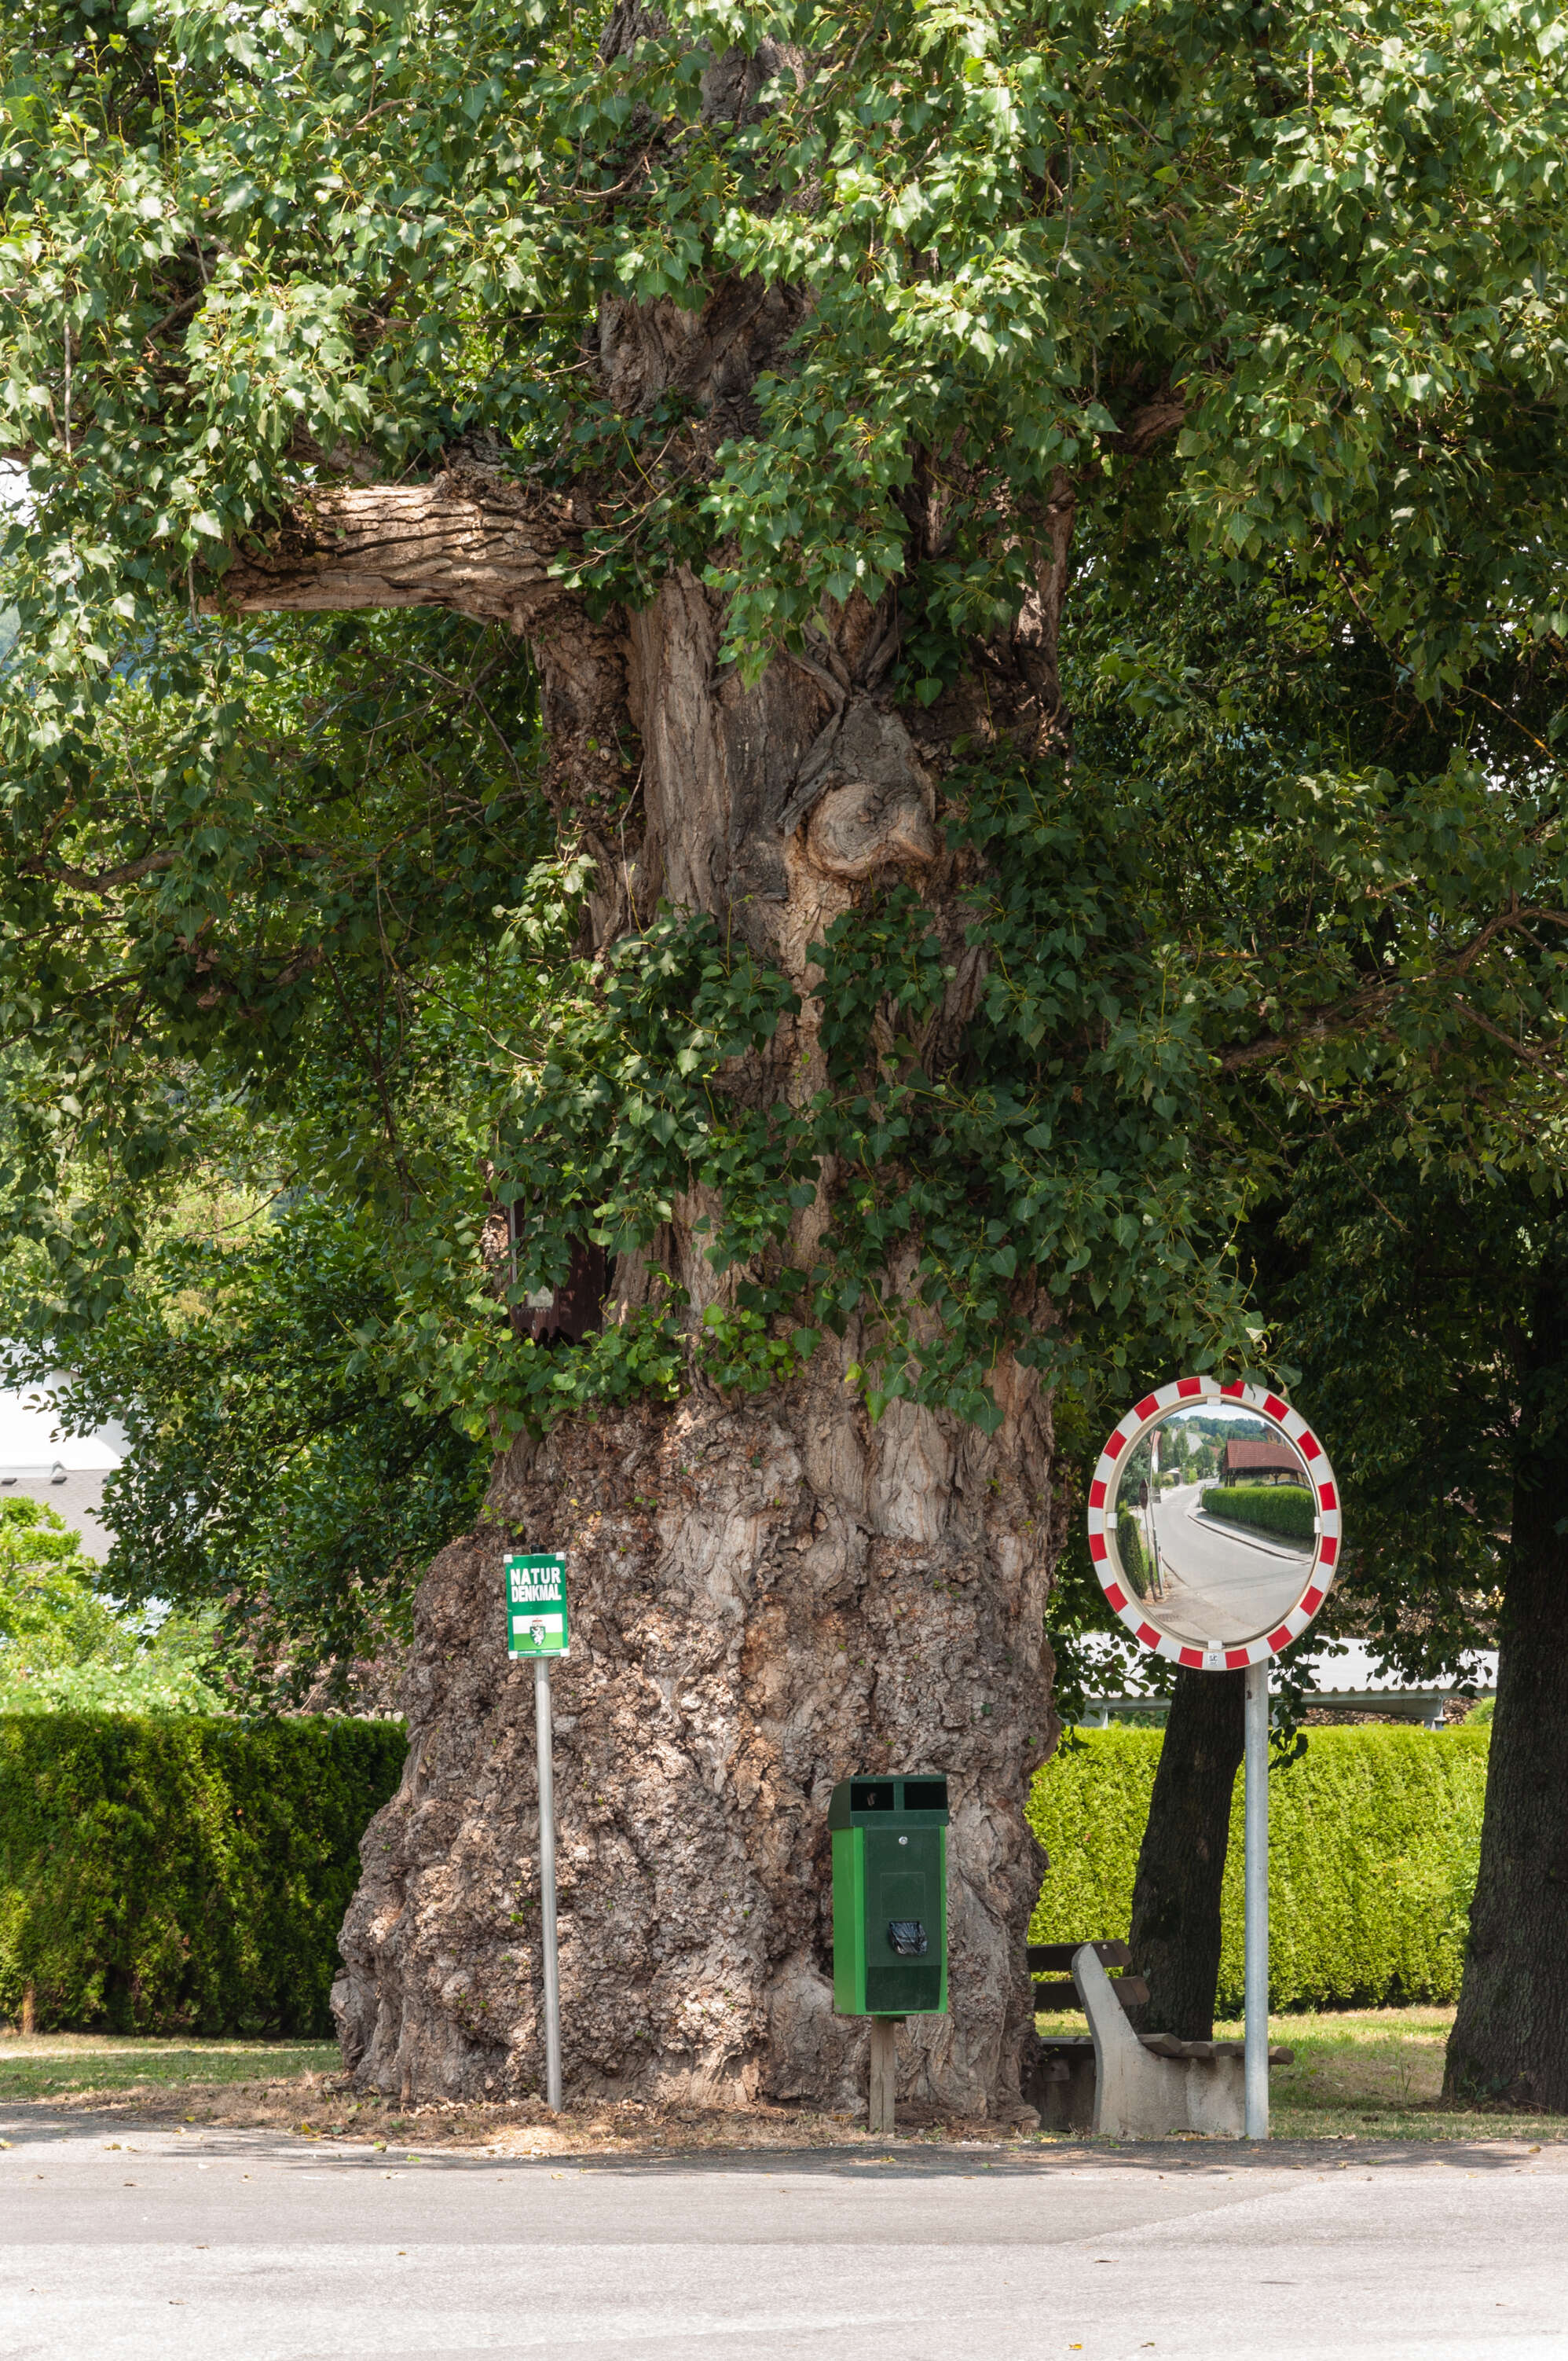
<box><xmin>826</xmin><ymin>1776</ymin><xmax>947</xmax><ymax>2016</ymax></box>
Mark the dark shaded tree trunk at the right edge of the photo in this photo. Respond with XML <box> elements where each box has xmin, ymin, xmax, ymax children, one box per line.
<box><xmin>1443</xmin><ymin>1266</ymin><xmax>1568</xmax><ymax>2113</ymax></box>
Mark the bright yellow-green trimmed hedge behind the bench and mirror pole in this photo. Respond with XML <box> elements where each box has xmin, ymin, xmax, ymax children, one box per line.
<box><xmin>1030</xmin><ymin>1724</ymin><xmax>1490</xmax><ymax>2016</ymax></box>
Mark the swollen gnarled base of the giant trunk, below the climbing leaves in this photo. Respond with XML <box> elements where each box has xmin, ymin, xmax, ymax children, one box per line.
<box><xmin>333</xmin><ymin>1365</ymin><xmax>1051</xmax><ymax>2117</ymax></box>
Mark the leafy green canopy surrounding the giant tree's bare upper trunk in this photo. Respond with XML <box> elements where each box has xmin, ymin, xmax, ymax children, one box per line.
<box><xmin>0</xmin><ymin>0</ymin><xmax>1568</xmax><ymax>1662</ymax></box>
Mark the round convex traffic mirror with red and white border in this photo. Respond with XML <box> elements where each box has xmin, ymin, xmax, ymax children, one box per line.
<box><xmin>1089</xmin><ymin>1377</ymin><xmax>1339</xmax><ymax>1672</ymax></box>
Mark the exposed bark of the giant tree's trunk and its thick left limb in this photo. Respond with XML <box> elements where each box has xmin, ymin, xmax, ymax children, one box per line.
<box><xmin>225</xmin><ymin>465</ymin><xmax>1053</xmax><ymax>2115</ymax></box>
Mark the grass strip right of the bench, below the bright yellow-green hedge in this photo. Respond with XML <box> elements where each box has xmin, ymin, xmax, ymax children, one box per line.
<box><xmin>1037</xmin><ymin>2007</ymin><xmax>1568</xmax><ymax>2142</ymax></box>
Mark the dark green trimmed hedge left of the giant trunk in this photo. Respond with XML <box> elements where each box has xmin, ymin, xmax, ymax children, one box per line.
<box><xmin>0</xmin><ymin>1714</ymin><xmax>406</xmax><ymax>2035</ymax></box>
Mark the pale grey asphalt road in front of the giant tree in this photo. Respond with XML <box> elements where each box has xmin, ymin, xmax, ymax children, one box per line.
<box><xmin>0</xmin><ymin>2106</ymin><xmax>1568</xmax><ymax>2361</ymax></box>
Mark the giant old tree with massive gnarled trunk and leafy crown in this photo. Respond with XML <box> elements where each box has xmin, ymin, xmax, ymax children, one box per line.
<box><xmin>0</xmin><ymin>0</ymin><xmax>1568</xmax><ymax>2108</ymax></box>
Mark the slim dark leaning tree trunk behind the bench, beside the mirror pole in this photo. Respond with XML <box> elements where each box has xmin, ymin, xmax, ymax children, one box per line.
<box><xmin>1129</xmin><ymin>1672</ymin><xmax>1244</xmax><ymax>2042</ymax></box>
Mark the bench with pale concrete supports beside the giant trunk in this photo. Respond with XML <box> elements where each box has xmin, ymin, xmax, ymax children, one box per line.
<box><xmin>1025</xmin><ymin>1943</ymin><xmax>1294</xmax><ymax>2139</ymax></box>
